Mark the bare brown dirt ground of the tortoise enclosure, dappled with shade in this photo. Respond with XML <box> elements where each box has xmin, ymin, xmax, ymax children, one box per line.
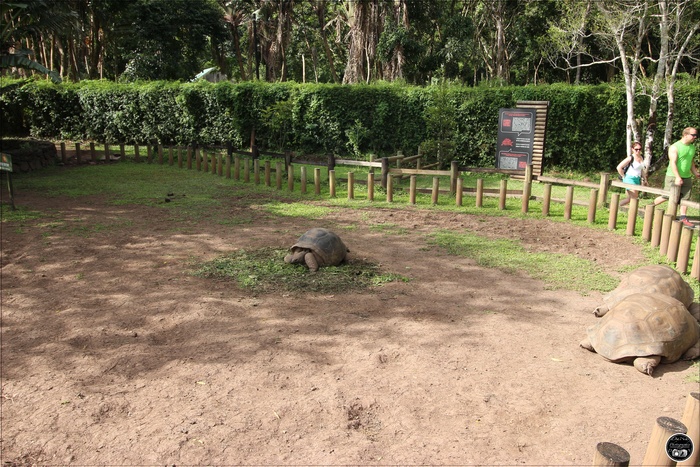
<box><xmin>0</xmin><ymin>185</ymin><xmax>699</xmax><ymax>466</ymax></box>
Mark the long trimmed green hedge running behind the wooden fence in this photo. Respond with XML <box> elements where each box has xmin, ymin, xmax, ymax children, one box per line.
<box><xmin>0</xmin><ymin>78</ymin><xmax>700</xmax><ymax>172</ymax></box>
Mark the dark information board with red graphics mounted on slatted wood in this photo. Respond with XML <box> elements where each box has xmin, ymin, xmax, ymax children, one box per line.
<box><xmin>496</xmin><ymin>109</ymin><xmax>536</xmax><ymax>170</ymax></box>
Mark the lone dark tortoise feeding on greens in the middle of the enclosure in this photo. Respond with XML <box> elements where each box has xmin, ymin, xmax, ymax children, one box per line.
<box><xmin>284</xmin><ymin>228</ymin><xmax>350</xmax><ymax>272</ymax></box>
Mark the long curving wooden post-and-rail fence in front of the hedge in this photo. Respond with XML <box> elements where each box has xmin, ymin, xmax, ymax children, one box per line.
<box><xmin>60</xmin><ymin>142</ymin><xmax>700</xmax><ymax>280</ymax></box>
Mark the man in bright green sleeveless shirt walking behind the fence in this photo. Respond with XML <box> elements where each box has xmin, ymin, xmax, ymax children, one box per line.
<box><xmin>654</xmin><ymin>127</ymin><xmax>700</xmax><ymax>227</ymax></box>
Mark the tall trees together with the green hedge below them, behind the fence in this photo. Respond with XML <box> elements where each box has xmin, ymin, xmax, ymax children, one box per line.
<box><xmin>0</xmin><ymin>0</ymin><xmax>700</xmax><ymax>171</ymax></box>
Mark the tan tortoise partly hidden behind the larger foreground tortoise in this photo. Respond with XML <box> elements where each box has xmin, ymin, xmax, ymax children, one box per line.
<box><xmin>593</xmin><ymin>264</ymin><xmax>693</xmax><ymax>317</ymax></box>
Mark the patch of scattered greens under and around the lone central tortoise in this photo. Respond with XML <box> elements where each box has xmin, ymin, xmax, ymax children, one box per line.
<box><xmin>194</xmin><ymin>248</ymin><xmax>409</xmax><ymax>293</ymax></box>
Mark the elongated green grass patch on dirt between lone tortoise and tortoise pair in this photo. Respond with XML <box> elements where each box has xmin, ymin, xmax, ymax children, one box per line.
<box><xmin>428</xmin><ymin>230</ymin><xmax>619</xmax><ymax>294</ymax></box>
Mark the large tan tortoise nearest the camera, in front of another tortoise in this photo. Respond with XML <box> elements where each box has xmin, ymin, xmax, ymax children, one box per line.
<box><xmin>581</xmin><ymin>293</ymin><xmax>700</xmax><ymax>375</ymax></box>
